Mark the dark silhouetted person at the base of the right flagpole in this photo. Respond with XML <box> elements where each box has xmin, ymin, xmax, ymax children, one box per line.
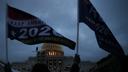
<box><xmin>70</xmin><ymin>54</ymin><xmax>80</xmax><ymax>72</ymax></box>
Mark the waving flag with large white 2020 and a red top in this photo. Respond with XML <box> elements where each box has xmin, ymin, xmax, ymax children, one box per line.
<box><xmin>7</xmin><ymin>6</ymin><xmax>75</xmax><ymax>50</ymax></box>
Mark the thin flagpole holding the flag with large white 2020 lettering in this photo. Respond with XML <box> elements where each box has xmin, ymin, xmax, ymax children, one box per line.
<box><xmin>5</xmin><ymin>0</ymin><xmax>9</xmax><ymax>63</ymax></box>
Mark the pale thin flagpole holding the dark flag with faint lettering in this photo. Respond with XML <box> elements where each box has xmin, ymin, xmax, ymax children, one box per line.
<box><xmin>76</xmin><ymin>0</ymin><xmax>79</xmax><ymax>54</ymax></box>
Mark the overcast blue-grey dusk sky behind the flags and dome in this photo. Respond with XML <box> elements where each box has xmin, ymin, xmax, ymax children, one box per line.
<box><xmin>0</xmin><ymin>0</ymin><xmax>128</xmax><ymax>61</ymax></box>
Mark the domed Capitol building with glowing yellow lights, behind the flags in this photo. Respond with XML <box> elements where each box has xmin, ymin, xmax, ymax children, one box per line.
<box><xmin>12</xmin><ymin>43</ymin><xmax>95</xmax><ymax>72</ymax></box>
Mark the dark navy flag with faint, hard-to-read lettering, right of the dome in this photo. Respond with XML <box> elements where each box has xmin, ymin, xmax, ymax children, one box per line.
<box><xmin>78</xmin><ymin>0</ymin><xmax>124</xmax><ymax>56</ymax></box>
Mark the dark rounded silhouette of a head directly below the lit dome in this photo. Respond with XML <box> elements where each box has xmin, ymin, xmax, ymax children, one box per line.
<box><xmin>32</xmin><ymin>63</ymin><xmax>50</xmax><ymax>72</ymax></box>
